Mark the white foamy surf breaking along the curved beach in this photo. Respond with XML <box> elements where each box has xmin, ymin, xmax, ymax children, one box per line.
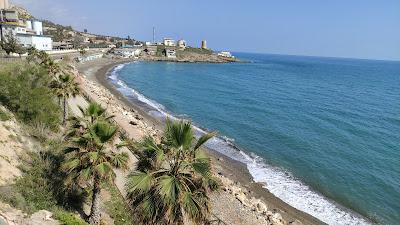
<box><xmin>109</xmin><ymin>64</ymin><xmax>372</xmax><ymax>225</ymax></box>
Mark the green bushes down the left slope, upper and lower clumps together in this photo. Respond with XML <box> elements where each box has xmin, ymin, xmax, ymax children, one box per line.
<box><xmin>0</xmin><ymin>57</ymin><xmax>87</xmax><ymax>225</ymax></box>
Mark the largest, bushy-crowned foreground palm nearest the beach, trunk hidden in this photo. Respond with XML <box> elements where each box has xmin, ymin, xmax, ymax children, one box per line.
<box><xmin>127</xmin><ymin>121</ymin><xmax>218</xmax><ymax>224</ymax></box>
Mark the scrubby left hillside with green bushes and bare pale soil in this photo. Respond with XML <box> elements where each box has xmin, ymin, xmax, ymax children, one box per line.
<box><xmin>0</xmin><ymin>56</ymin><xmax>132</xmax><ymax>225</ymax></box>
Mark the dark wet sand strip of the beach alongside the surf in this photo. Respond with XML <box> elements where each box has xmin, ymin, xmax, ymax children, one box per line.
<box><xmin>78</xmin><ymin>60</ymin><xmax>325</xmax><ymax>224</ymax></box>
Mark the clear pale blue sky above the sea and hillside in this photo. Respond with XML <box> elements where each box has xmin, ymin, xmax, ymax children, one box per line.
<box><xmin>10</xmin><ymin>0</ymin><xmax>400</xmax><ymax>60</ymax></box>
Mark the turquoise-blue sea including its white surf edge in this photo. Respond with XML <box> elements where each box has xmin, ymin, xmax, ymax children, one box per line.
<box><xmin>110</xmin><ymin>54</ymin><xmax>400</xmax><ymax>225</ymax></box>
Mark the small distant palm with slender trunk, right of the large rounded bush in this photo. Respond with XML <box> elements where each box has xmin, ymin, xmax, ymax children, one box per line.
<box><xmin>50</xmin><ymin>74</ymin><xmax>80</xmax><ymax>125</ymax></box>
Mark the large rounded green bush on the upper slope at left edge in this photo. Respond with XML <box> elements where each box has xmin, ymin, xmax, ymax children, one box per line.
<box><xmin>0</xmin><ymin>62</ymin><xmax>61</xmax><ymax>131</ymax></box>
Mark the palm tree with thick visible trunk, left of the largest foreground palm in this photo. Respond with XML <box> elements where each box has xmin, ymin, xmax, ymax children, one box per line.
<box><xmin>61</xmin><ymin>121</ymin><xmax>129</xmax><ymax>224</ymax></box>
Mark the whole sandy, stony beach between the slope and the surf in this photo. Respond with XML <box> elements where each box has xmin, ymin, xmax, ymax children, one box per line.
<box><xmin>76</xmin><ymin>59</ymin><xmax>324</xmax><ymax>224</ymax></box>
